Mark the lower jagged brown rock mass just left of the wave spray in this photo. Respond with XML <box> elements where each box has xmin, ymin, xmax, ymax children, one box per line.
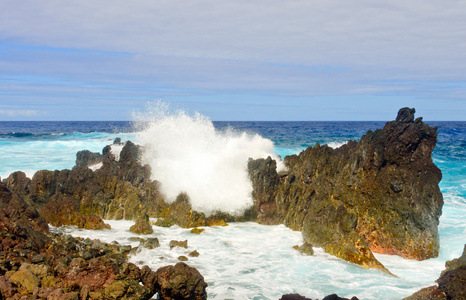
<box><xmin>6</xmin><ymin>141</ymin><xmax>168</xmax><ymax>225</ymax></box>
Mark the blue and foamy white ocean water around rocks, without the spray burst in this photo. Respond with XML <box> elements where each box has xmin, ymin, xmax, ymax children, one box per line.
<box><xmin>0</xmin><ymin>122</ymin><xmax>466</xmax><ymax>299</ymax></box>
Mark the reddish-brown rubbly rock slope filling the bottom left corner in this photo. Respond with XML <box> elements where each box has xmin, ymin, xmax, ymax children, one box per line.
<box><xmin>0</xmin><ymin>183</ymin><xmax>155</xmax><ymax>299</ymax></box>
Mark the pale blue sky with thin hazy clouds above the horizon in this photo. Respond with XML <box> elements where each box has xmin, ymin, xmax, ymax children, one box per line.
<box><xmin>0</xmin><ymin>0</ymin><xmax>466</xmax><ymax>121</ymax></box>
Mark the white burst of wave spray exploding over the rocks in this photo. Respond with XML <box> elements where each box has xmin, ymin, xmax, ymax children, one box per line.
<box><xmin>136</xmin><ymin>102</ymin><xmax>285</xmax><ymax>215</ymax></box>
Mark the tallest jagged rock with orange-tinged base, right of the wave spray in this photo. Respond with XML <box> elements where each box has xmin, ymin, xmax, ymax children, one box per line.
<box><xmin>248</xmin><ymin>108</ymin><xmax>443</xmax><ymax>270</ymax></box>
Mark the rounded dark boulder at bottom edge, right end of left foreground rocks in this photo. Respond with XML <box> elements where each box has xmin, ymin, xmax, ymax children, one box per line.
<box><xmin>156</xmin><ymin>262</ymin><xmax>207</xmax><ymax>300</ymax></box>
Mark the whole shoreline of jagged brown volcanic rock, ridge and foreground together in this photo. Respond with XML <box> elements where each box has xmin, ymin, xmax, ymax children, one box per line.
<box><xmin>0</xmin><ymin>108</ymin><xmax>465</xmax><ymax>299</ymax></box>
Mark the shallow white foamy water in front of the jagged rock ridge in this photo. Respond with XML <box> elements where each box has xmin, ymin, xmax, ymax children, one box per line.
<box><xmin>55</xmin><ymin>220</ymin><xmax>444</xmax><ymax>299</ymax></box>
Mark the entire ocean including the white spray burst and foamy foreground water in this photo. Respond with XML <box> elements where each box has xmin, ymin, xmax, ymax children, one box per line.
<box><xmin>0</xmin><ymin>118</ymin><xmax>466</xmax><ymax>299</ymax></box>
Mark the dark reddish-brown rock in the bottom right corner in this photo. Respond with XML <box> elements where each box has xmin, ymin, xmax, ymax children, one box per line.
<box><xmin>404</xmin><ymin>245</ymin><xmax>466</xmax><ymax>300</ymax></box>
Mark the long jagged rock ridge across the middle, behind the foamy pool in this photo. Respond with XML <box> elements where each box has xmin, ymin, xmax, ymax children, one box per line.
<box><xmin>2</xmin><ymin>108</ymin><xmax>443</xmax><ymax>271</ymax></box>
